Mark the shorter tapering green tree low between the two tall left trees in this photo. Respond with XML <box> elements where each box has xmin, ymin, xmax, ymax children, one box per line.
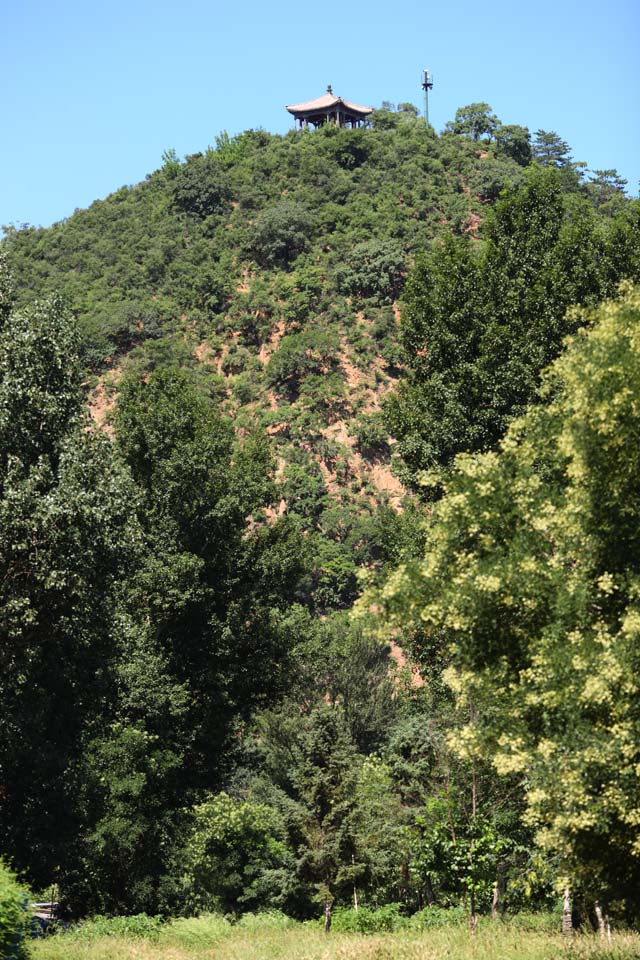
<box><xmin>70</xmin><ymin>624</ymin><xmax>190</xmax><ymax>914</ymax></box>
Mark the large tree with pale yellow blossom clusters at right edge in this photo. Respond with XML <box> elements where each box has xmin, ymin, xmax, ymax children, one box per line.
<box><xmin>376</xmin><ymin>288</ymin><xmax>640</xmax><ymax>917</ymax></box>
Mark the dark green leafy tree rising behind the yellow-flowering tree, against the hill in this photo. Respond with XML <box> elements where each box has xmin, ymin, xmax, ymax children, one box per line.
<box><xmin>388</xmin><ymin>169</ymin><xmax>640</xmax><ymax>485</ymax></box>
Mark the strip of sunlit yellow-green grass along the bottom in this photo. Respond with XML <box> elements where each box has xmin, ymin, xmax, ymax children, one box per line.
<box><xmin>30</xmin><ymin>917</ymin><xmax>640</xmax><ymax>960</ymax></box>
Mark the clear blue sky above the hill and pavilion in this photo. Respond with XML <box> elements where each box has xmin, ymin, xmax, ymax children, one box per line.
<box><xmin>0</xmin><ymin>0</ymin><xmax>640</xmax><ymax>225</ymax></box>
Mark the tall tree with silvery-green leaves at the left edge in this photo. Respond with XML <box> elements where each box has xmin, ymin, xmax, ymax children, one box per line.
<box><xmin>0</xmin><ymin>262</ymin><xmax>141</xmax><ymax>885</ymax></box>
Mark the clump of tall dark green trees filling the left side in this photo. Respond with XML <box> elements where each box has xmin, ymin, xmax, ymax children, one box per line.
<box><xmin>0</xmin><ymin>255</ymin><xmax>301</xmax><ymax>909</ymax></box>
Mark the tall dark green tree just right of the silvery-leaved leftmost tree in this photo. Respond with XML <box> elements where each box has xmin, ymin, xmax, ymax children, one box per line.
<box><xmin>116</xmin><ymin>370</ymin><xmax>303</xmax><ymax>788</ymax></box>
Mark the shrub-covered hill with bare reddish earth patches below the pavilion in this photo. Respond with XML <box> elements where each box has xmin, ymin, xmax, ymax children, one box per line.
<box><xmin>4</xmin><ymin>104</ymin><xmax>636</xmax><ymax>606</ymax></box>
